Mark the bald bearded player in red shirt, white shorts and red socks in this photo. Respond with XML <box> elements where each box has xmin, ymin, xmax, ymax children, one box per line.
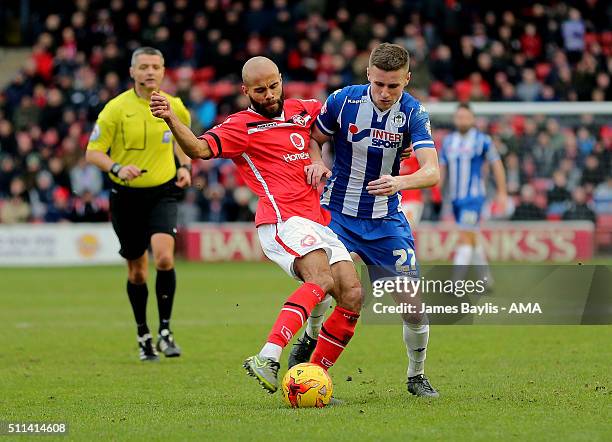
<box><xmin>150</xmin><ymin>57</ymin><xmax>362</xmax><ymax>393</ymax></box>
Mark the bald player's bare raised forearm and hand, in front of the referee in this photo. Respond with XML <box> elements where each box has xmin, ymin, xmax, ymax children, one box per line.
<box><xmin>149</xmin><ymin>92</ymin><xmax>214</xmax><ymax>160</ymax></box>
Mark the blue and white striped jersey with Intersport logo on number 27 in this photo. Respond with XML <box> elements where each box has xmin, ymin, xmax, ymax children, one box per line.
<box><xmin>316</xmin><ymin>85</ymin><xmax>434</xmax><ymax>218</ymax></box>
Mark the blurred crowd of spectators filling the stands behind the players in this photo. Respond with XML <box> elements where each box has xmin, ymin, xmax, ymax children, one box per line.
<box><xmin>0</xmin><ymin>0</ymin><xmax>612</xmax><ymax>224</ymax></box>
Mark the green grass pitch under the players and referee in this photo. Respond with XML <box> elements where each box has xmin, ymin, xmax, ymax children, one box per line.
<box><xmin>0</xmin><ymin>263</ymin><xmax>612</xmax><ymax>441</ymax></box>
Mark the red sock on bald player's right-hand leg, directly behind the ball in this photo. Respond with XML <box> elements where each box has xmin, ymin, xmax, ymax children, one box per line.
<box><xmin>310</xmin><ymin>307</ymin><xmax>359</xmax><ymax>370</ymax></box>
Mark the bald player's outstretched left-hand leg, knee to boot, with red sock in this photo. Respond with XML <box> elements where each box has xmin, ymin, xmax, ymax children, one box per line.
<box><xmin>244</xmin><ymin>249</ymin><xmax>334</xmax><ymax>393</ymax></box>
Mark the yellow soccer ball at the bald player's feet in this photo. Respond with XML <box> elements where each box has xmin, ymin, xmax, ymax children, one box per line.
<box><xmin>282</xmin><ymin>363</ymin><xmax>334</xmax><ymax>408</ymax></box>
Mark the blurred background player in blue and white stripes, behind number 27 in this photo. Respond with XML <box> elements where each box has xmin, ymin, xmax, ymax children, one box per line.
<box><xmin>440</xmin><ymin>103</ymin><xmax>507</xmax><ymax>284</ymax></box>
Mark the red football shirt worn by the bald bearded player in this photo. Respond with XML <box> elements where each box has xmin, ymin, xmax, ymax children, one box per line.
<box><xmin>200</xmin><ymin>99</ymin><xmax>329</xmax><ymax>226</ymax></box>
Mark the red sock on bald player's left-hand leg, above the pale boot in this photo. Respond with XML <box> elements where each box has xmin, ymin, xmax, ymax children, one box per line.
<box><xmin>268</xmin><ymin>282</ymin><xmax>326</xmax><ymax>347</ymax></box>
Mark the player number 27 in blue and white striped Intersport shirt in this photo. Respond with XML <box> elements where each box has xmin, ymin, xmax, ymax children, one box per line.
<box><xmin>295</xmin><ymin>43</ymin><xmax>439</xmax><ymax>397</ymax></box>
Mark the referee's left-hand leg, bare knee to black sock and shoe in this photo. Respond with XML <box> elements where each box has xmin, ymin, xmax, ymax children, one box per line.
<box><xmin>127</xmin><ymin>252</ymin><xmax>159</xmax><ymax>361</ymax></box>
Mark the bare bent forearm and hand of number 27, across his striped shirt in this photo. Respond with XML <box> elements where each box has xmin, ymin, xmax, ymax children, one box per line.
<box><xmin>366</xmin><ymin>147</ymin><xmax>440</xmax><ymax>196</ymax></box>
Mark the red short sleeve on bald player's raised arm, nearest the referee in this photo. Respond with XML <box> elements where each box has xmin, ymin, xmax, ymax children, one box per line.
<box><xmin>198</xmin><ymin>116</ymin><xmax>248</xmax><ymax>158</ymax></box>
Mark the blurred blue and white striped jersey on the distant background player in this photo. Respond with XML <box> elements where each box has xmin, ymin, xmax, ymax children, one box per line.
<box><xmin>440</xmin><ymin>128</ymin><xmax>499</xmax><ymax>203</ymax></box>
